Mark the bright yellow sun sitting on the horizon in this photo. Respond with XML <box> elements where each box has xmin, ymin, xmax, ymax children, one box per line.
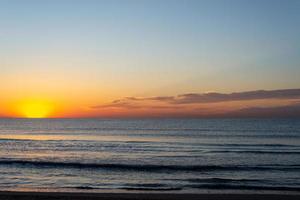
<box><xmin>20</xmin><ymin>100</ymin><xmax>53</xmax><ymax>118</ymax></box>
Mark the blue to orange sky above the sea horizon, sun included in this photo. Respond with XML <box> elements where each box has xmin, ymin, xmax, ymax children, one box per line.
<box><xmin>0</xmin><ymin>0</ymin><xmax>300</xmax><ymax>117</ymax></box>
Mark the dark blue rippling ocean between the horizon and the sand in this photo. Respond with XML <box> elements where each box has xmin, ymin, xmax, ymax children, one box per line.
<box><xmin>0</xmin><ymin>119</ymin><xmax>300</xmax><ymax>193</ymax></box>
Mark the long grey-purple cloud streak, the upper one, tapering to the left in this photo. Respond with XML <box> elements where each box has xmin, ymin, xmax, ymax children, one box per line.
<box><xmin>91</xmin><ymin>89</ymin><xmax>300</xmax><ymax>109</ymax></box>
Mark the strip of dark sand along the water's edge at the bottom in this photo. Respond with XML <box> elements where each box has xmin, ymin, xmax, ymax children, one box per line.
<box><xmin>0</xmin><ymin>192</ymin><xmax>300</xmax><ymax>200</ymax></box>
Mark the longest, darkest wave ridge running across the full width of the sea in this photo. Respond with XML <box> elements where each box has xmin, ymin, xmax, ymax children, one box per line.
<box><xmin>0</xmin><ymin>160</ymin><xmax>300</xmax><ymax>172</ymax></box>
